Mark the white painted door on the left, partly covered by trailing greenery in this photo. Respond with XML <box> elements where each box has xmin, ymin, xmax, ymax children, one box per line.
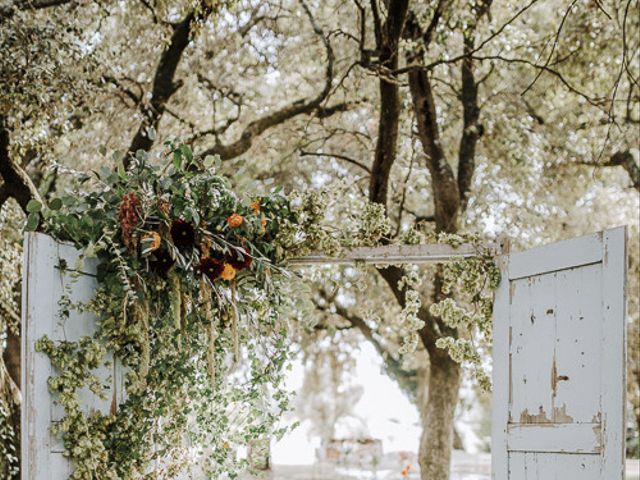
<box><xmin>22</xmin><ymin>233</ymin><xmax>124</xmax><ymax>480</ymax></box>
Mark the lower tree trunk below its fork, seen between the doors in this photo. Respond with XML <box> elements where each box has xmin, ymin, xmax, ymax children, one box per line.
<box><xmin>418</xmin><ymin>356</ymin><xmax>461</xmax><ymax>480</ymax></box>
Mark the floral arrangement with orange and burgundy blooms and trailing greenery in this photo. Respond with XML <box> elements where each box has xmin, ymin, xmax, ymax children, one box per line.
<box><xmin>27</xmin><ymin>143</ymin><xmax>312</xmax><ymax>480</ymax></box>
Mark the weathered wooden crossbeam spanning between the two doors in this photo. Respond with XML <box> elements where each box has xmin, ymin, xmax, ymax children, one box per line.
<box><xmin>289</xmin><ymin>243</ymin><xmax>502</xmax><ymax>265</ymax></box>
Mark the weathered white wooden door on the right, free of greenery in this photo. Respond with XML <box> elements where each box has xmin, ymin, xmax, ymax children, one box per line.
<box><xmin>492</xmin><ymin>228</ymin><xmax>626</xmax><ymax>480</ymax></box>
